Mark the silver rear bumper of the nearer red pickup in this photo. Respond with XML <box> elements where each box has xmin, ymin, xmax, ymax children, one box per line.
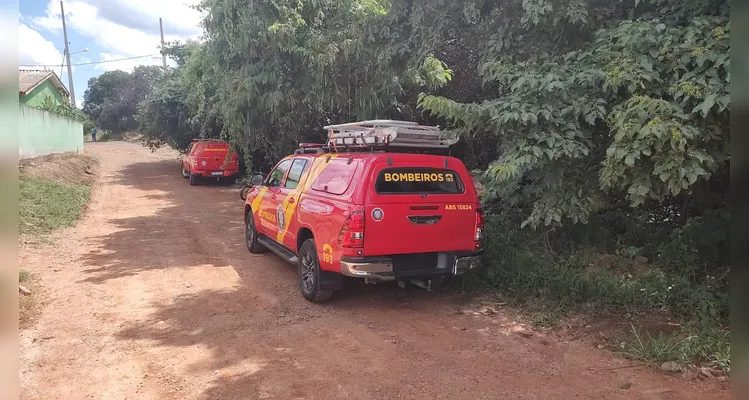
<box><xmin>341</xmin><ymin>252</ymin><xmax>481</xmax><ymax>281</ymax></box>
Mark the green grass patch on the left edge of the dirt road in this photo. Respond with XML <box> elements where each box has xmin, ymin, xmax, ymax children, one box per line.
<box><xmin>19</xmin><ymin>177</ymin><xmax>91</xmax><ymax>236</ymax></box>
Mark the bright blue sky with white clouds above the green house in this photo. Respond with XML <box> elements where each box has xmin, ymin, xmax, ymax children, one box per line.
<box><xmin>18</xmin><ymin>0</ymin><xmax>202</xmax><ymax>107</ymax></box>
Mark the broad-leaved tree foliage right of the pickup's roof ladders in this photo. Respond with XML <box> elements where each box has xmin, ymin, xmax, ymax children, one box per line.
<box><xmin>419</xmin><ymin>1</ymin><xmax>730</xmax><ymax>227</ymax></box>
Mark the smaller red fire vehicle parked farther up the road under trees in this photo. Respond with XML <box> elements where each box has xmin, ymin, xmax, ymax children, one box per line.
<box><xmin>180</xmin><ymin>139</ymin><xmax>239</xmax><ymax>185</ymax></box>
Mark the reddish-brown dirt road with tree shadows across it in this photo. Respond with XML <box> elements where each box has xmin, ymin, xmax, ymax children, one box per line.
<box><xmin>20</xmin><ymin>142</ymin><xmax>728</xmax><ymax>400</ymax></box>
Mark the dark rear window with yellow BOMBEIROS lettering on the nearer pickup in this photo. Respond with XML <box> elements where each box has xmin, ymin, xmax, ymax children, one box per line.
<box><xmin>375</xmin><ymin>167</ymin><xmax>465</xmax><ymax>194</ymax></box>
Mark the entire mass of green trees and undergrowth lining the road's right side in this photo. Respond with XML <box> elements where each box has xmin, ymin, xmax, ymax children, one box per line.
<box><xmin>79</xmin><ymin>0</ymin><xmax>730</xmax><ymax>371</ymax></box>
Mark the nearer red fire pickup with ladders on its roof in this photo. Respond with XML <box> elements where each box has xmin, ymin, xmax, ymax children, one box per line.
<box><xmin>244</xmin><ymin>120</ymin><xmax>484</xmax><ymax>302</ymax></box>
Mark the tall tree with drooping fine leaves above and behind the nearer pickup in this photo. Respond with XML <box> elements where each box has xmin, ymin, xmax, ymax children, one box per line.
<box><xmin>191</xmin><ymin>0</ymin><xmax>451</xmax><ymax>168</ymax></box>
